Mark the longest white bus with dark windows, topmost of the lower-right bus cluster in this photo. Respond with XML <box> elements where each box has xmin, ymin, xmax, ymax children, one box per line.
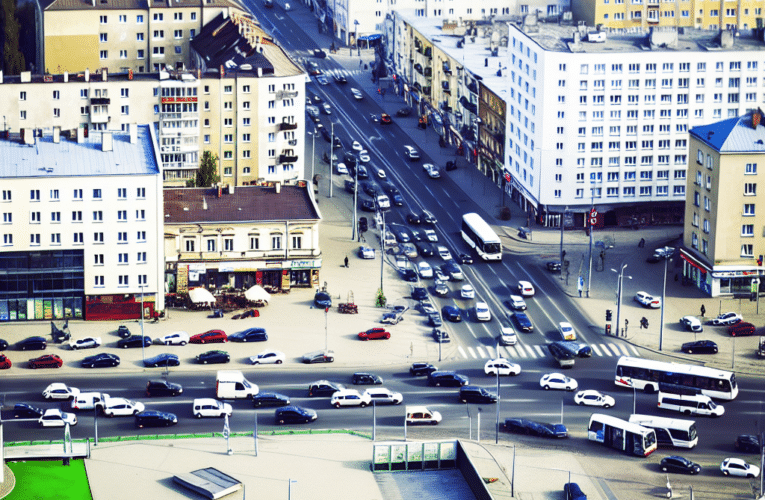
<box><xmin>614</xmin><ymin>356</ymin><xmax>738</xmax><ymax>400</ymax></box>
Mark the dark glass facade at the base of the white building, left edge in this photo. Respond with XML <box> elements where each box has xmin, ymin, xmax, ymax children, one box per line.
<box><xmin>0</xmin><ymin>250</ymin><xmax>85</xmax><ymax>321</ymax></box>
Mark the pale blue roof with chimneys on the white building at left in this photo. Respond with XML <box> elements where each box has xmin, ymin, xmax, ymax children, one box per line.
<box><xmin>0</xmin><ymin>125</ymin><xmax>160</xmax><ymax>178</ymax></box>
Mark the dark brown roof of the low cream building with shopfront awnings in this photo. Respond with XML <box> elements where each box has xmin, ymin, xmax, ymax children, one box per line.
<box><xmin>164</xmin><ymin>183</ymin><xmax>321</xmax><ymax>224</ymax></box>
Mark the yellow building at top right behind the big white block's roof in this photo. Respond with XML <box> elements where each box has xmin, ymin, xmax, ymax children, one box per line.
<box><xmin>571</xmin><ymin>0</ymin><xmax>763</xmax><ymax>31</ymax></box>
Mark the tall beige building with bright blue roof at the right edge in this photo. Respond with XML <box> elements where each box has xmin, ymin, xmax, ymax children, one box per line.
<box><xmin>680</xmin><ymin>108</ymin><xmax>765</xmax><ymax>297</ymax></box>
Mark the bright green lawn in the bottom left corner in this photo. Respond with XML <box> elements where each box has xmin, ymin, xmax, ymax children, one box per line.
<box><xmin>5</xmin><ymin>460</ymin><xmax>93</xmax><ymax>500</ymax></box>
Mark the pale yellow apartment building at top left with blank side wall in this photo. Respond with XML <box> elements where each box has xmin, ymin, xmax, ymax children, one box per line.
<box><xmin>39</xmin><ymin>0</ymin><xmax>245</xmax><ymax>74</ymax></box>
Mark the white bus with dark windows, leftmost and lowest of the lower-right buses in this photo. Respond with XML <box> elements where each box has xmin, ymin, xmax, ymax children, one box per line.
<box><xmin>587</xmin><ymin>413</ymin><xmax>657</xmax><ymax>457</ymax></box>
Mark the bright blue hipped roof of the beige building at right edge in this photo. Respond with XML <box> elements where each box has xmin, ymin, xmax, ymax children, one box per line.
<box><xmin>691</xmin><ymin>109</ymin><xmax>765</xmax><ymax>154</ymax></box>
